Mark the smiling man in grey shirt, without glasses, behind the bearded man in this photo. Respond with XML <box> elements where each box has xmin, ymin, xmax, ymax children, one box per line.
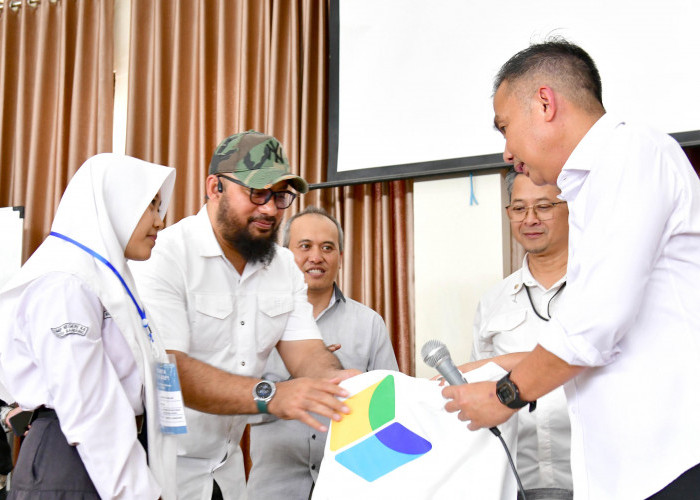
<box><xmin>248</xmin><ymin>206</ymin><xmax>399</xmax><ymax>500</ymax></box>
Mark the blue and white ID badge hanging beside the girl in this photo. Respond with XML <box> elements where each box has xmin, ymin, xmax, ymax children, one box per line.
<box><xmin>156</xmin><ymin>354</ymin><xmax>187</xmax><ymax>434</ymax></box>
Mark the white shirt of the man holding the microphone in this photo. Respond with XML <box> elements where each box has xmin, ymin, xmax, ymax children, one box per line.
<box><xmin>539</xmin><ymin>114</ymin><xmax>700</xmax><ymax>500</ymax></box>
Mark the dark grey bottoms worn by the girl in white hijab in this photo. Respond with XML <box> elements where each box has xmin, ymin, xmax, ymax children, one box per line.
<box><xmin>8</xmin><ymin>412</ymin><xmax>100</xmax><ymax>500</ymax></box>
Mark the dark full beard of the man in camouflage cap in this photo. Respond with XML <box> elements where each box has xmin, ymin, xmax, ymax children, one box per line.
<box><xmin>216</xmin><ymin>196</ymin><xmax>279</xmax><ymax>265</ymax></box>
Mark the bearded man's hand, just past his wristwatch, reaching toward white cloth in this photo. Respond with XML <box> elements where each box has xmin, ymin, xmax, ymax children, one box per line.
<box><xmin>267</xmin><ymin>376</ymin><xmax>357</xmax><ymax>432</ymax></box>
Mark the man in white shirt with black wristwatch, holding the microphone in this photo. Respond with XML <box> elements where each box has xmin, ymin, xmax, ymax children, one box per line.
<box><xmin>443</xmin><ymin>40</ymin><xmax>700</xmax><ymax>499</ymax></box>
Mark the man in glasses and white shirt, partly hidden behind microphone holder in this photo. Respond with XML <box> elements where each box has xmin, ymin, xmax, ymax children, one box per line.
<box><xmin>460</xmin><ymin>170</ymin><xmax>572</xmax><ymax>499</ymax></box>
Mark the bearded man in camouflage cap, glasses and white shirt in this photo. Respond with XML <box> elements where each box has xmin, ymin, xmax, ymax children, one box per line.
<box><xmin>133</xmin><ymin>131</ymin><xmax>356</xmax><ymax>500</ymax></box>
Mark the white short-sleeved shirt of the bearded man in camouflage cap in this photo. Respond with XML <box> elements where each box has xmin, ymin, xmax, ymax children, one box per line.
<box><xmin>132</xmin><ymin>206</ymin><xmax>321</xmax><ymax>499</ymax></box>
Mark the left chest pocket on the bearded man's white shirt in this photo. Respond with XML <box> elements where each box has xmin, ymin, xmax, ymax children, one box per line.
<box><xmin>190</xmin><ymin>293</ymin><xmax>234</xmax><ymax>351</ymax></box>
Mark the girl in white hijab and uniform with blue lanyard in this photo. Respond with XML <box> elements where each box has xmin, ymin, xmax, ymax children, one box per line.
<box><xmin>0</xmin><ymin>153</ymin><xmax>176</xmax><ymax>500</ymax></box>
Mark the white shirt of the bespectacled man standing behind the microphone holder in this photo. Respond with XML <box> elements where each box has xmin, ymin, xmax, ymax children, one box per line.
<box><xmin>467</xmin><ymin>255</ymin><xmax>573</xmax><ymax>490</ymax></box>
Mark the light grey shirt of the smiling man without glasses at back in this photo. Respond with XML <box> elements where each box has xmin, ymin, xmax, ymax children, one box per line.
<box><xmin>248</xmin><ymin>286</ymin><xmax>398</xmax><ymax>500</ymax></box>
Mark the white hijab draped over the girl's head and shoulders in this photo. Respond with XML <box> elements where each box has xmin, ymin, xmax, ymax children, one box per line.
<box><xmin>0</xmin><ymin>153</ymin><xmax>176</xmax><ymax>499</ymax></box>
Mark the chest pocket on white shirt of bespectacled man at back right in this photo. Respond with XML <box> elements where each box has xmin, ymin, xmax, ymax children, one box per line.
<box><xmin>484</xmin><ymin>309</ymin><xmax>537</xmax><ymax>355</ymax></box>
